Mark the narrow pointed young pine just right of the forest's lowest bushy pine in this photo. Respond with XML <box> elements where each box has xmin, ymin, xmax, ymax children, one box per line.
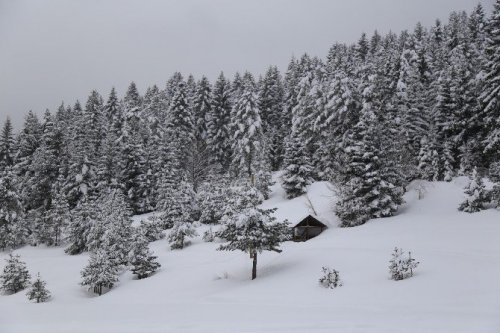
<box><xmin>128</xmin><ymin>230</ymin><xmax>161</xmax><ymax>279</ymax></box>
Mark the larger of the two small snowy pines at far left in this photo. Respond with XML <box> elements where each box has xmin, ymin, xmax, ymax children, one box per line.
<box><xmin>0</xmin><ymin>253</ymin><xmax>31</xmax><ymax>294</ymax></box>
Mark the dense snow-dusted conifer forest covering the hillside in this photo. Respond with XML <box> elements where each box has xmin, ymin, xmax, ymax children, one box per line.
<box><xmin>0</xmin><ymin>0</ymin><xmax>500</xmax><ymax>282</ymax></box>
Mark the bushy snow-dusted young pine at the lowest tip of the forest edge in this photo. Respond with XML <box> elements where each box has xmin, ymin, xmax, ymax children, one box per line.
<box><xmin>81</xmin><ymin>249</ymin><xmax>118</xmax><ymax>296</ymax></box>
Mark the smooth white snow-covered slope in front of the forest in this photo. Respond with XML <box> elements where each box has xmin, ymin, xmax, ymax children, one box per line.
<box><xmin>0</xmin><ymin>179</ymin><xmax>500</xmax><ymax>333</ymax></box>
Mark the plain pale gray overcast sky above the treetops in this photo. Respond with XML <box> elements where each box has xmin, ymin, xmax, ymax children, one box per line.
<box><xmin>0</xmin><ymin>0</ymin><xmax>494</xmax><ymax>128</ymax></box>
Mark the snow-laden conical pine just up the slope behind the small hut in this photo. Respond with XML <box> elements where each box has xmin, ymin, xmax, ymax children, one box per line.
<box><xmin>281</xmin><ymin>137</ymin><xmax>312</xmax><ymax>199</ymax></box>
